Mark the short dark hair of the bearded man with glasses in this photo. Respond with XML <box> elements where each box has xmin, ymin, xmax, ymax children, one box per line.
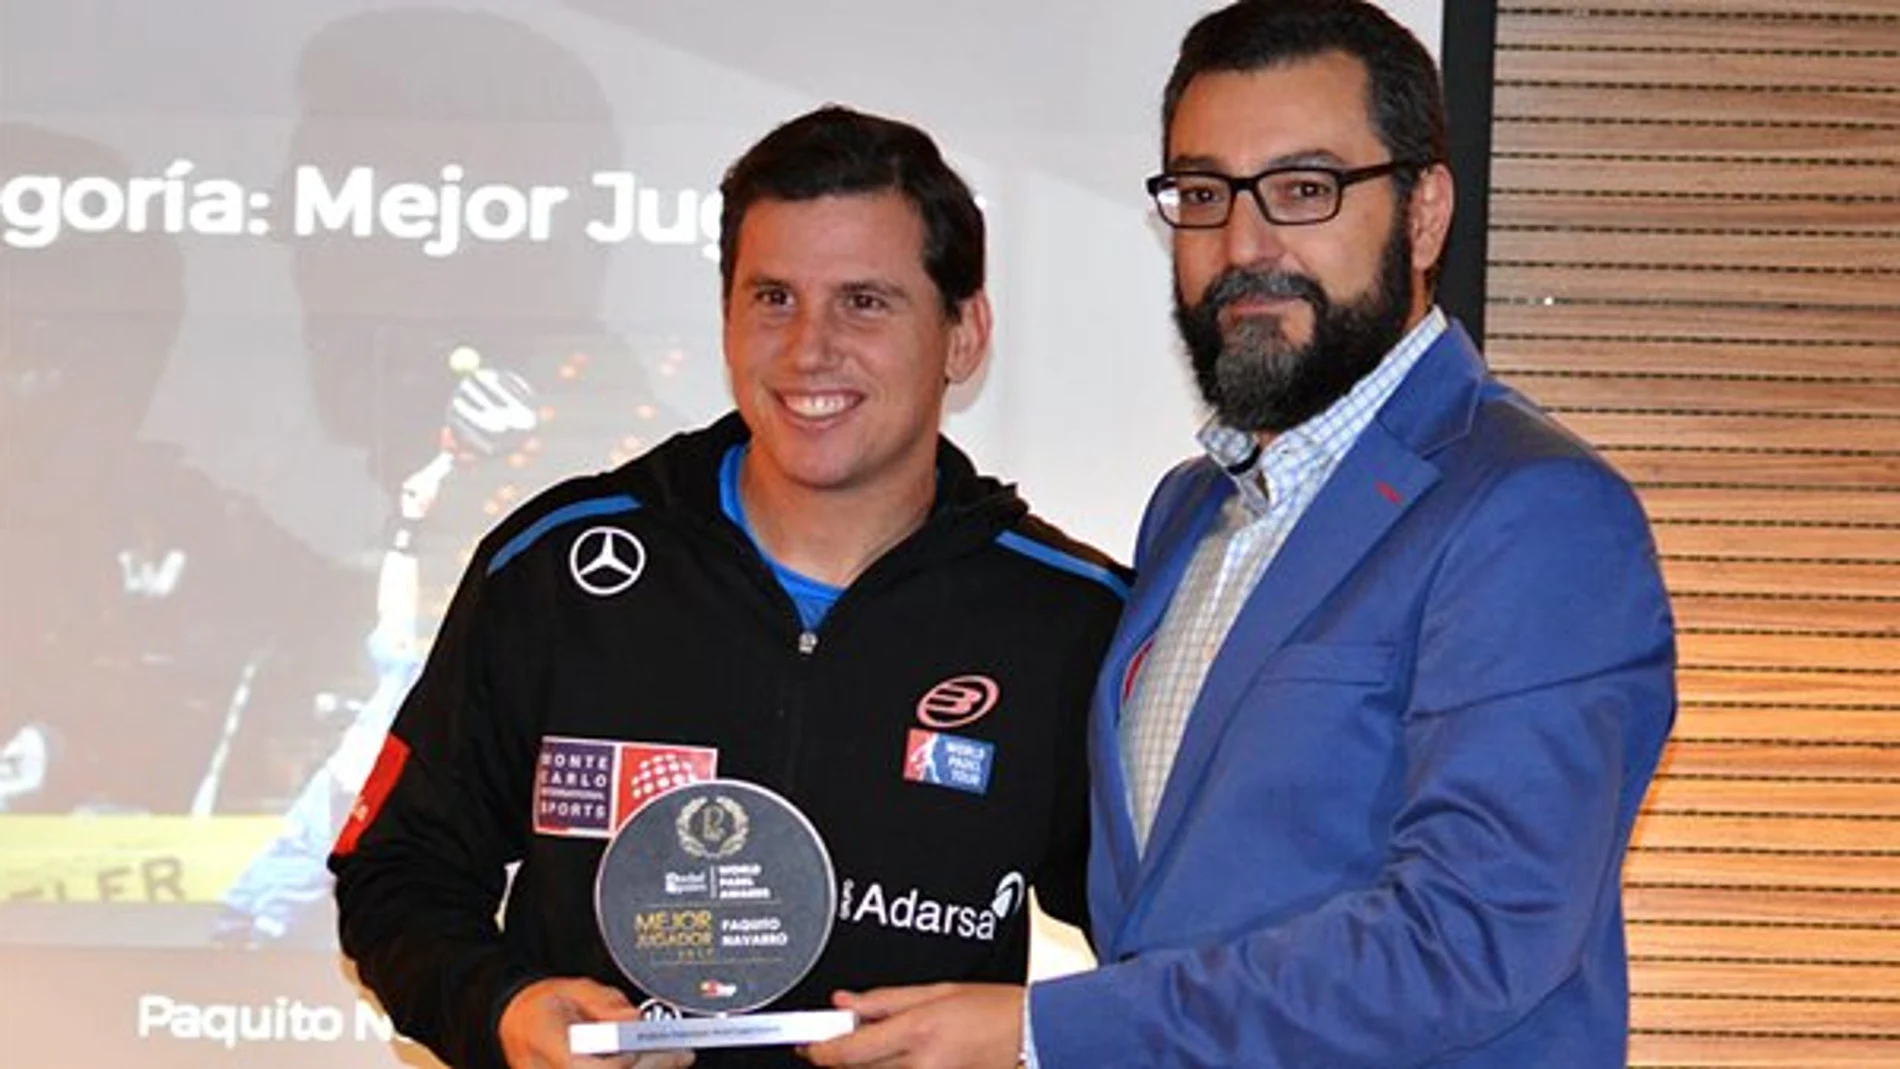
<box><xmin>1161</xmin><ymin>0</ymin><xmax>1446</xmax><ymax>197</ymax></box>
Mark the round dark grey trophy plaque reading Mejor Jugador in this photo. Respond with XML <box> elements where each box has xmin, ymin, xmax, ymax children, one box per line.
<box><xmin>595</xmin><ymin>780</ymin><xmax>838</xmax><ymax>1014</ymax></box>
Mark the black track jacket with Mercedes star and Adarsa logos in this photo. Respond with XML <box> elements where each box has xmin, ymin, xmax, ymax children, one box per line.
<box><xmin>331</xmin><ymin>416</ymin><xmax>1125</xmax><ymax>1069</ymax></box>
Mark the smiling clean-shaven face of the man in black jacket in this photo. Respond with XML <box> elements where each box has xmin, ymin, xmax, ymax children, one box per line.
<box><xmin>726</xmin><ymin>190</ymin><xmax>990</xmax><ymax>499</ymax></box>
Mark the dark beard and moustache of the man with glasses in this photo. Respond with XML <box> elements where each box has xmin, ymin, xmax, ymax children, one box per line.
<box><xmin>1174</xmin><ymin>216</ymin><xmax>1414</xmax><ymax>435</ymax></box>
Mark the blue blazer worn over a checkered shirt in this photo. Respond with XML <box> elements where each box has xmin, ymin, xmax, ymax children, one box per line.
<box><xmin>1030</xmin><ymin>325</ymin><xmax>1676</xmax><ymax>1069</ymax></box>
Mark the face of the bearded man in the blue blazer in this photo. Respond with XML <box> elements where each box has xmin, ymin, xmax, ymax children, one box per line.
<box><xmin>1167</xmin><ymin>53</ymin><xmax>1452</xmax><ymax>433</ymax></box>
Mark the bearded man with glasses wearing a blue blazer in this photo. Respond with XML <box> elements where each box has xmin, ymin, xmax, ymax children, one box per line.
<box><xmin>809</xmin><ymin>0</ymin><xmax>1674</xmax><ymax>1069</ymax></box>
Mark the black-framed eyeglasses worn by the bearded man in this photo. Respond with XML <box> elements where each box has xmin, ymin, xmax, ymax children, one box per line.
<box><xmin>1148</xmin><ymin>159</ymin><xmax>1427</xmax><ymax>230</ymax></box>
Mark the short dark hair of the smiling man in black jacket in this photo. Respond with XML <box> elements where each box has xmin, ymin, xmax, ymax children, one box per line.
<box><xmin>718</xmin><ymin>104</ymin><xmax>984</xmax><ymax>319</ymax></box>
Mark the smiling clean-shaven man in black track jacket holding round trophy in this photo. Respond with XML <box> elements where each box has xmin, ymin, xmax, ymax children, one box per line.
<box><xmin>331</xmin><ymin>108</ymin><xmax>1125</xmax><ymax>1069</ymax></box>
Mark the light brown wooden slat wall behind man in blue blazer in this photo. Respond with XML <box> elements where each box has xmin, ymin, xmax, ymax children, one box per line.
<box><xmin>1486</xmin><ymin>0</ymin><xmax>1900</xmax><ymax>1069</ymax></box>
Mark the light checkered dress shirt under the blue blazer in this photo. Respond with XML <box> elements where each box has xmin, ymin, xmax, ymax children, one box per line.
<box><xmin>1121</xmin><ymin>308</ymin><xmax>1446</xmax><ymax>851</ymax></box>
